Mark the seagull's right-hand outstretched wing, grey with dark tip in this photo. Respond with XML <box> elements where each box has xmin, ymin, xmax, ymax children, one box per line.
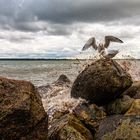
<box><xmin>104</xmin><ymin>36</ymin><xmax>123</xmax><ymax>48</ymax></box>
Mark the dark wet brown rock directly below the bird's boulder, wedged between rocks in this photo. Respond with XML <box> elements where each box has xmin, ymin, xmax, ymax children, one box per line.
<box><xmin>73</xmin><ymin>103</ymin><xmax>106</xmax><ymax>134</ymax></box>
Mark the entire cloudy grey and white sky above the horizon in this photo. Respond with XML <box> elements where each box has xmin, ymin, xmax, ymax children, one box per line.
<box><xmin>0</xmin><ymin>0</ymin><xmax>140</xmax><ymax>58</ymax></box>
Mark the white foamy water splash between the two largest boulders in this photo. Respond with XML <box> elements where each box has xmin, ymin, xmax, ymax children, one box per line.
<box><xmin>42</xmin><ymin>82</ymin><xmax>85</xmax><ymax>122</ymax></box>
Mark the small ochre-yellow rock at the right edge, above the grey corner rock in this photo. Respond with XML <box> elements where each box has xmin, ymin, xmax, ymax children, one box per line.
<box><xmin>125</xmin><ymin>99</ymin><xmax>140</xmax><ymax>116</ymax></box>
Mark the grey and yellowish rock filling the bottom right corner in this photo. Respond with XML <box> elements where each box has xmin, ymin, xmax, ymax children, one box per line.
<box><xmin>96</xmin><ymin>115</ymin><xmax>140</xmax><ymax>140</ymax></box>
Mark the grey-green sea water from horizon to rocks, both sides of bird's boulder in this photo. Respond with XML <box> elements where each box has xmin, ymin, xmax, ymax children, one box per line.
<box><xmin>0</xmin><ymin>60</ymin><xmax>140</xmax><ymax>86</ymax></box>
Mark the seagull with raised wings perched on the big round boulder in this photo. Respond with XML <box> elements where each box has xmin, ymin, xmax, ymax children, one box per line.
<box><xmin>82</xmin><ymin>36</ymin><xmax>123</xmax><ymax>59</ymax></box>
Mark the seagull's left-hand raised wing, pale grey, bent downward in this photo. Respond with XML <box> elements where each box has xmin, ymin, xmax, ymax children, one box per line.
<box><xmin>82</xmin><ymin>37</ymin><xmax>97</xmax><ymax>51</ymax></box>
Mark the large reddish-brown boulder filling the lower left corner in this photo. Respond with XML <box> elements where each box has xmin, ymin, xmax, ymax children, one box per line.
<box><xmin>0</xmin><ymin>77</ymin><xmax>48</xmax><ymax>140</ymax></box>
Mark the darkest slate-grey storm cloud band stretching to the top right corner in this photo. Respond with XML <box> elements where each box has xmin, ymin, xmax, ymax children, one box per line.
<box><xmin>23</xmin><ymin>0</ymin><xmax>140</xmax><ymax>23</ymax></box>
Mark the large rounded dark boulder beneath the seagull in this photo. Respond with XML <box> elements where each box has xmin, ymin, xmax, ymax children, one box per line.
<box><xmin>71</xmin><ymin>59</ymin><xmax>132</xmax><ymax>105</ymax></box>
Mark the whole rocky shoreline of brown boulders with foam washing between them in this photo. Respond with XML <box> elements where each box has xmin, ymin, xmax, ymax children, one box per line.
<box><xmin>0</xmin><ymin>59</ymin><xmax>140</xmax><ymax>140</ymax></box>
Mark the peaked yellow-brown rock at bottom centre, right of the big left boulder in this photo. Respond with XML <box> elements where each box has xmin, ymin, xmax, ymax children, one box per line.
<box><xmin>48</xmin><ymin>115</ymin><xmax>93</xmax><ymax>140</ymax></box>
